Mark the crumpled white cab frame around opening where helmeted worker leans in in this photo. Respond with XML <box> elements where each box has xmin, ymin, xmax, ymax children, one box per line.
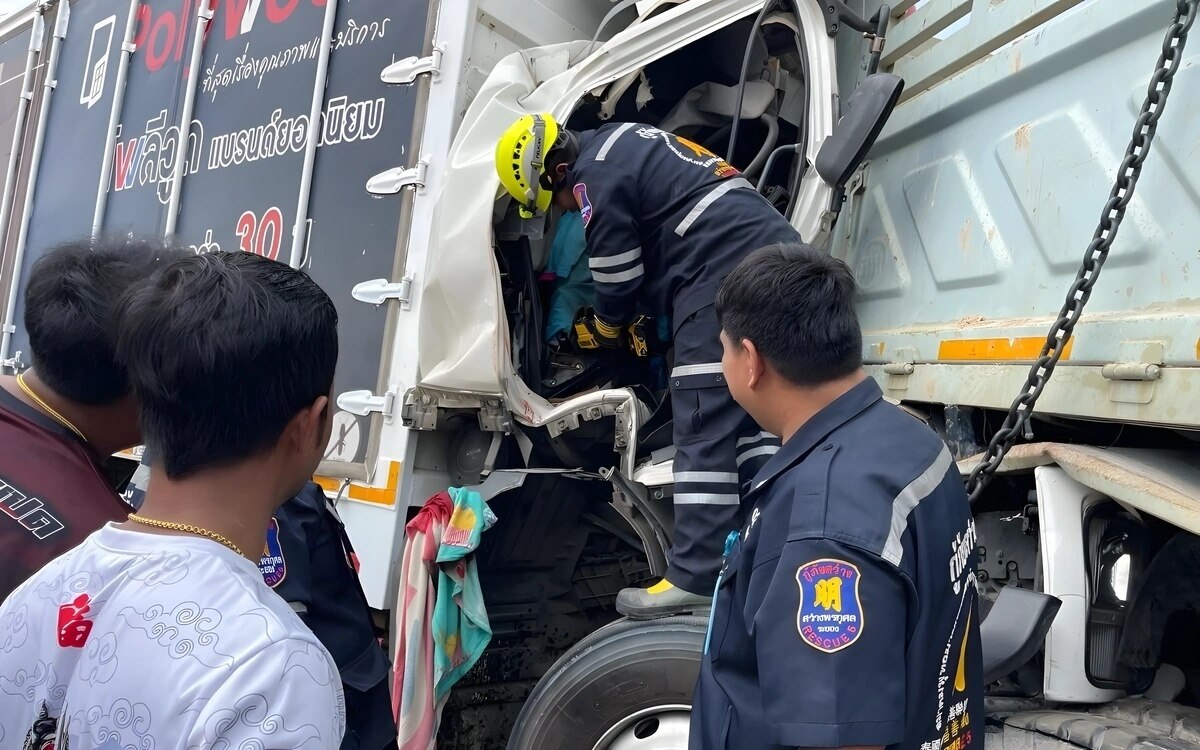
<box><xmin>414</xmin><ymin>0</ymin><xmax>836</xmax><ymax>415</ymax></box>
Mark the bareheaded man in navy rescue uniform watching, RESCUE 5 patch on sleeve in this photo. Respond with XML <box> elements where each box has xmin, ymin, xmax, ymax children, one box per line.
<box><xmin>689</xmin><ymin>245</ymin><xmax>984</xmax><ymax>750</ymax></box>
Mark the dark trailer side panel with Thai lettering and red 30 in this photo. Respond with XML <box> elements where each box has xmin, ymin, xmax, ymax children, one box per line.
<box><xmin>0</xmin><ymin>0</ymin><xmax>430</xmax><ymax>475</ymax></box>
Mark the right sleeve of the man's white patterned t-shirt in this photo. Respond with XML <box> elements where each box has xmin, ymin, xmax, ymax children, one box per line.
<box><xmin>186</xmin><ymin>638</ymin><xmax>346</xmax><ymax>750</ymax></box>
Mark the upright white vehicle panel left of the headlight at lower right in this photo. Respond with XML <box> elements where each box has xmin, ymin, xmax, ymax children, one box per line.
<box><xmin>1033</xmin><ymin>467</ymin><xmax>1122</xmax><ymax>703</ymax></box>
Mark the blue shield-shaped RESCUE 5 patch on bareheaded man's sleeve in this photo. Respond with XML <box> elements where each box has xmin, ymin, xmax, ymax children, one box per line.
<box><xmin>796</xmin><ymin>558</ymin><xmax>863</xmax><ymax>654</ymax></box>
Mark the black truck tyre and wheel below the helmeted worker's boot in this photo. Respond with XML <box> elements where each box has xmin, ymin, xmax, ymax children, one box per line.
<box><xmin>509</xmin><ymin>617</ymin><xmax>707</xmax><ymax>750</ymax></box>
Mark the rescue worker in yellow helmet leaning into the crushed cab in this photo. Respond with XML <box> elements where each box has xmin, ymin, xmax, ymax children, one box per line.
<box><xmin>496</xmin><ymin>114</ymin><xmax>800</xmax><ymax>618</ymax></box>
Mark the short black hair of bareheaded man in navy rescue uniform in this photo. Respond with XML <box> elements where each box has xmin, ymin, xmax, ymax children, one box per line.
<box><xmin>716</xmin><ymin>242</ymin><xmax>863</xmax><ymax>386</ymax></box>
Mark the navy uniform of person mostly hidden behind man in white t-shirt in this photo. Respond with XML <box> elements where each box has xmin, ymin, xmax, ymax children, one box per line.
<box><xmin>127</xmin><ymin>458</ymin><xmax>397</xmax><ymax>750</ymax></box>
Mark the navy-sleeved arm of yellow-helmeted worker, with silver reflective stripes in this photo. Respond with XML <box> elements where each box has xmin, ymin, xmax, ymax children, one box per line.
<box><xmin>574</xmin><ymin>162</ymin><xmax>646</xmax><ymax>326</ymax></box>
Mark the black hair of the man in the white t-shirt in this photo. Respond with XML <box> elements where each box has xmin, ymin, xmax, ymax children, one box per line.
<box><xmin>116</xmin><ymin>251</ymin><xmax>337</xmax><ymax>479</ymax></box>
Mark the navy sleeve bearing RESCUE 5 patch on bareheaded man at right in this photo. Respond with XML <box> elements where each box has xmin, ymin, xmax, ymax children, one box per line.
<box><xmin>746</xmin><ymin>540</ymin><xmax>907</xmax><ymax>748</ymax></box>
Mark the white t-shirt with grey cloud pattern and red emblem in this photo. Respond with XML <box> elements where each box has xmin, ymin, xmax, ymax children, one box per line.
<box><xmin>0</xmin><ymin>524</ymin><xmax>346</xmax><ymax>750</ymax></box>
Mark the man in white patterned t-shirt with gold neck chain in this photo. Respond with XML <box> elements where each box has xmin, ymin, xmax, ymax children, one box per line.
<box><xmin>0</xmin><ymin>252</ymin><xmax>346</xmax><ymax>750</ymax></box>
